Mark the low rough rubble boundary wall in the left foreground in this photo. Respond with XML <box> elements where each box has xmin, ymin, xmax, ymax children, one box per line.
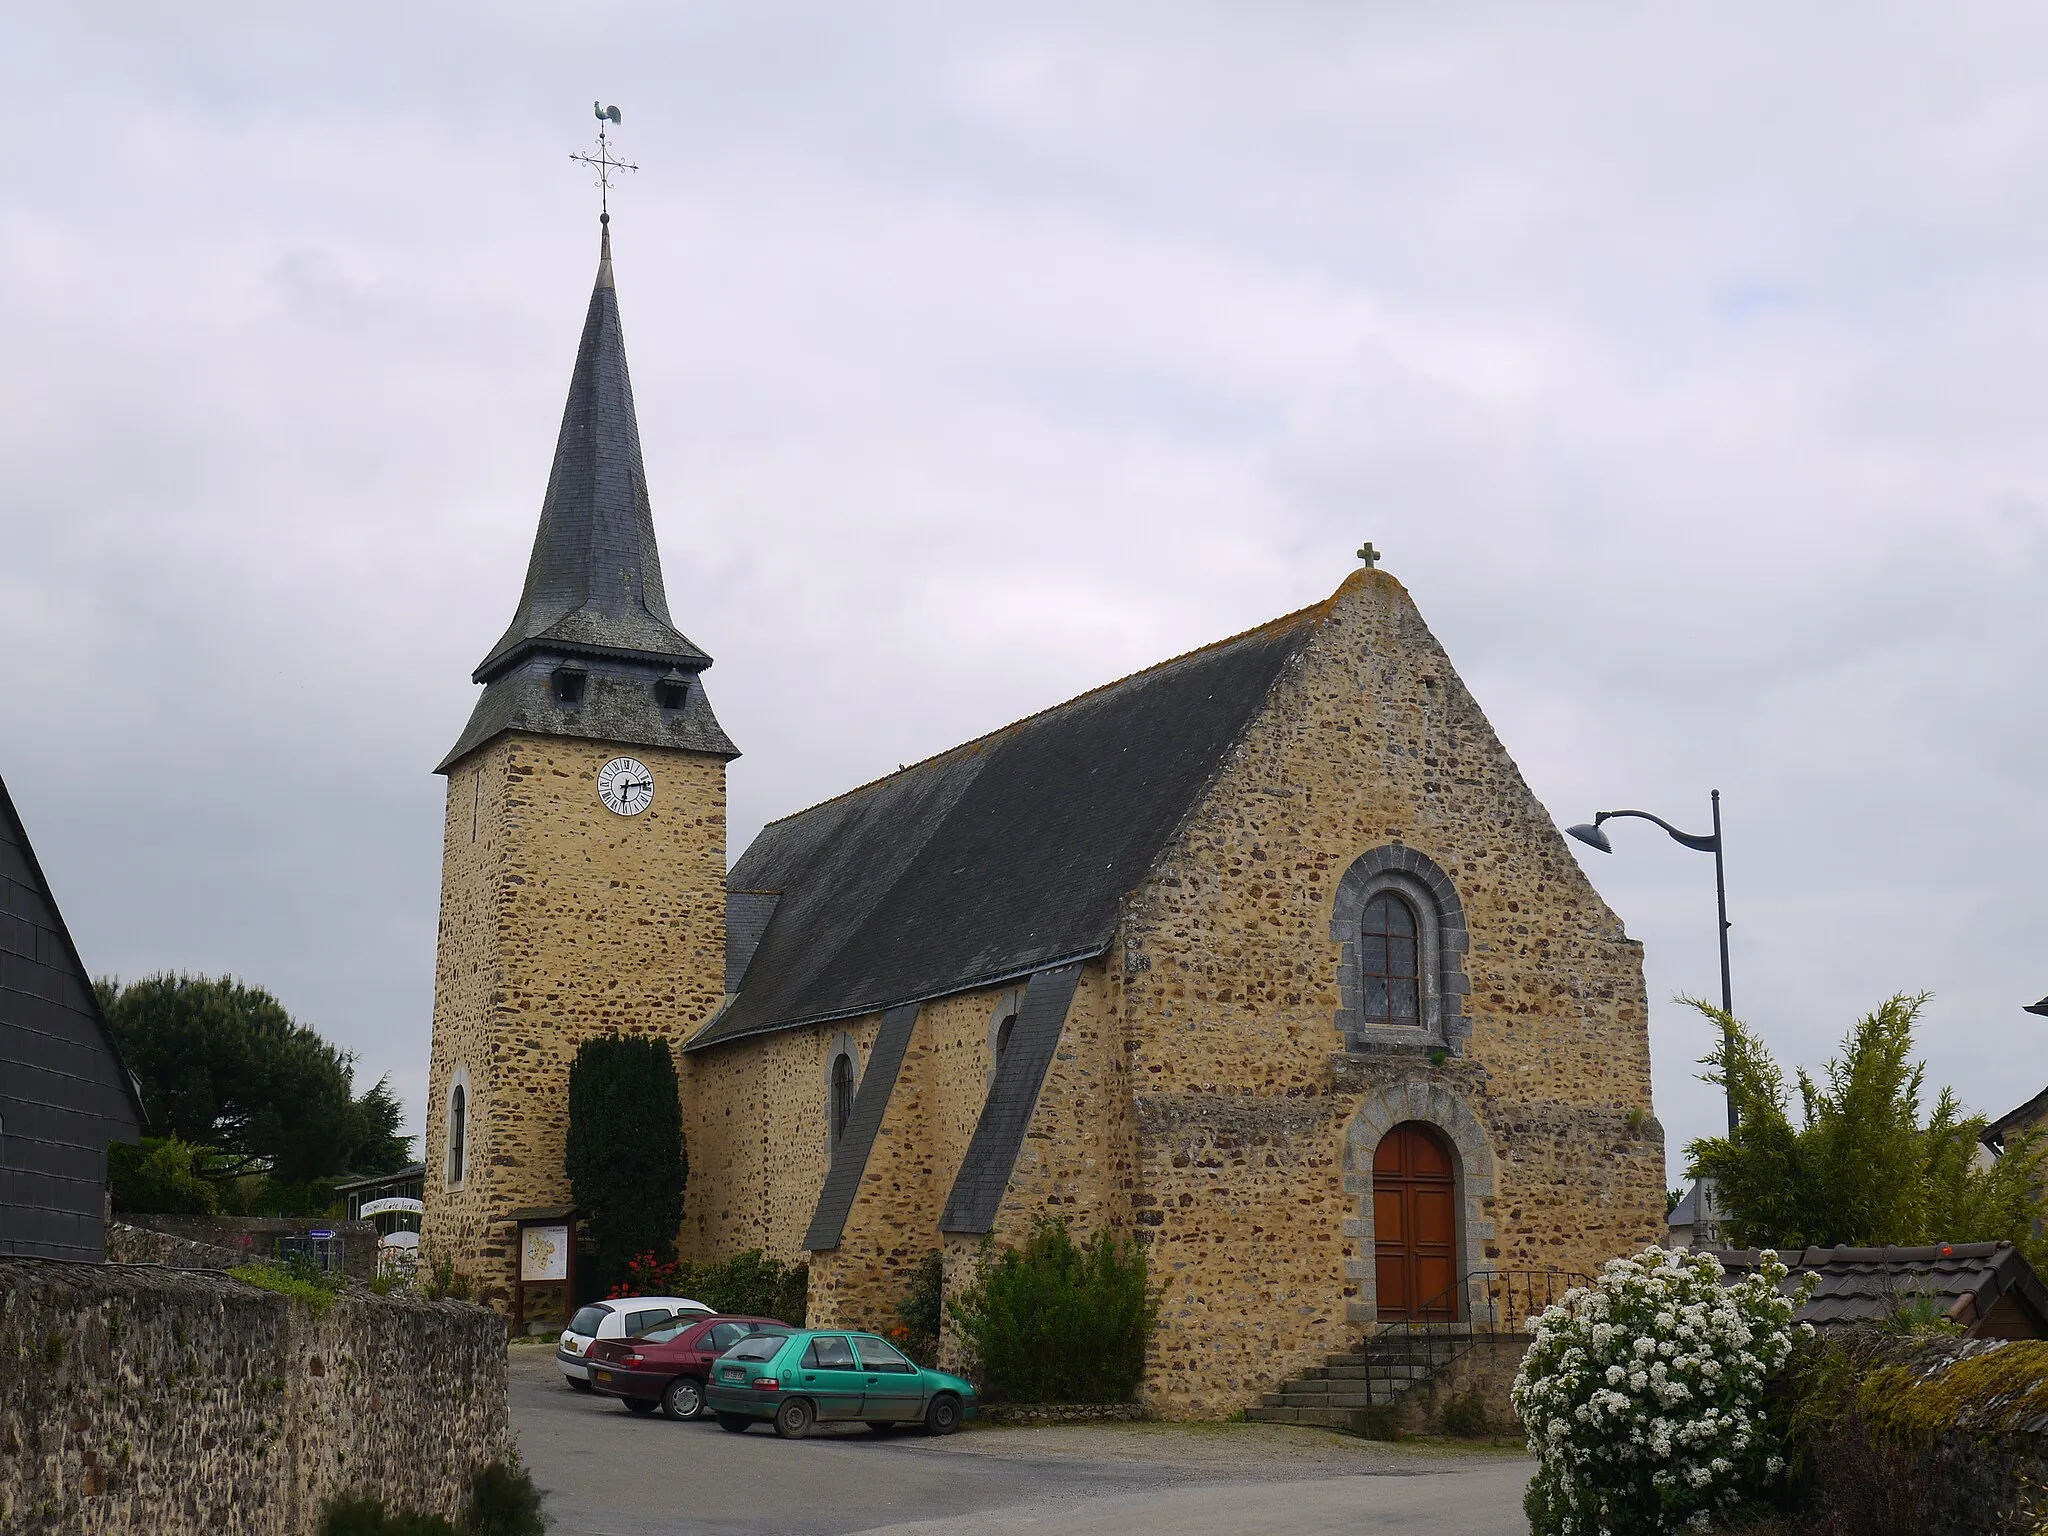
<box><xmin>0</xmin><ymin>1260</ymin><xmax>510</xmax><ymax>1536</ymax></box>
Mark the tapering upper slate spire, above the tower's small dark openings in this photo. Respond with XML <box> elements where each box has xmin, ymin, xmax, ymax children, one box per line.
<box><xmin>475</xmin><ymin>215</ymin><xmax>711</xmax><ymax>682</ymax></box>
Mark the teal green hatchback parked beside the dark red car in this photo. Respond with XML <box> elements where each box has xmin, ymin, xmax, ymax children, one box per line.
<box><xmin>705</xmin><ymin>1329</ymin><xmax>975</xmax><ymax>1440</ymax></box>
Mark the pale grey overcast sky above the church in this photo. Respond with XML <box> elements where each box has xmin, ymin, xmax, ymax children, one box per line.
<box><xmin>0</xmin><ymin>0</ymin><xmax>2048</xmax><ymax>1176</ymax></box>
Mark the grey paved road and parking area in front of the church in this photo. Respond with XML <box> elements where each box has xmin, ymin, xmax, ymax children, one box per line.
<box><xmin>512</xmin><ymin>1346</ymin><xmax>1532</xmax><ymax>1536</ymax></box>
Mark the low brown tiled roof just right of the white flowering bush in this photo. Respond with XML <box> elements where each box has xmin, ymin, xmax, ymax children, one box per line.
<box><xmin>1714</xmin><ymin>1243</ymin><xmax>2048</xmax><ymax>1333</ymax></box>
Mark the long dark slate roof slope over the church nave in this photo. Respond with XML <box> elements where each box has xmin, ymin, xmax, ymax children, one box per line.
<box><xmin>688</xmin><ymin>604</ymin><xmax>1327</xmax><ymax>1051</ymax></box>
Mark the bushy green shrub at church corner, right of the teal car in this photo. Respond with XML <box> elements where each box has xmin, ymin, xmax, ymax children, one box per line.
<box><xmin>946</xmin><ymin>1221</ymin><xmax>1159</xmax><ymax>1403</ymax></box>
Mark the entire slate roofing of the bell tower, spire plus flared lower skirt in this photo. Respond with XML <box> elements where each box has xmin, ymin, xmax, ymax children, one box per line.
<box><xmin>440</xmin><ymin>215</ymin><xmax>739</xmax><ymax>772</ymax></box>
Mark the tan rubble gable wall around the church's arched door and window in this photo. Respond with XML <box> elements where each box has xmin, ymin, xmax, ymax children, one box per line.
<box><xmin>1122</xmin><ymin>571</ymin><xmax>1663</xmax><ymax>1417</ymax></box>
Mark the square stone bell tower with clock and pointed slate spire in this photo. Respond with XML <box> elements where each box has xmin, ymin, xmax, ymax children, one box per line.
<box><xmin>422</xmin><ymin>217</ymin><xmax>739</xmax><ymax>1307</ymax></box>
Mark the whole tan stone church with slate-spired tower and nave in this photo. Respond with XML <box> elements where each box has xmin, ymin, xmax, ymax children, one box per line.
<box><xmin>426</xmin><ymin>219</ymin><xmax>1663</xmax><ymax>1417</ymax></box>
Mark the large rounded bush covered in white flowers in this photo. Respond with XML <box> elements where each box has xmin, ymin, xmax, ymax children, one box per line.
<box><xmin>1513</xmin><ymin>1247</ymin><xmax>1806</xmax><ymax>1536</ymax></box>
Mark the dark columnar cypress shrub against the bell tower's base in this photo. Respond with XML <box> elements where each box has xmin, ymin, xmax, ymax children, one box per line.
<box><xmin>565</xmin><ymin>1034</ymin><xmax>690</xmax><ymax>1294</ymax></box>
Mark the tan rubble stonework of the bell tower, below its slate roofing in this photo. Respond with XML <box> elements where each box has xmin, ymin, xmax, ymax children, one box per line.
<box><xmin>422</xmin><ymin>733</ymin><xmax>725</xmax><ymax>1317</ymax></box>
